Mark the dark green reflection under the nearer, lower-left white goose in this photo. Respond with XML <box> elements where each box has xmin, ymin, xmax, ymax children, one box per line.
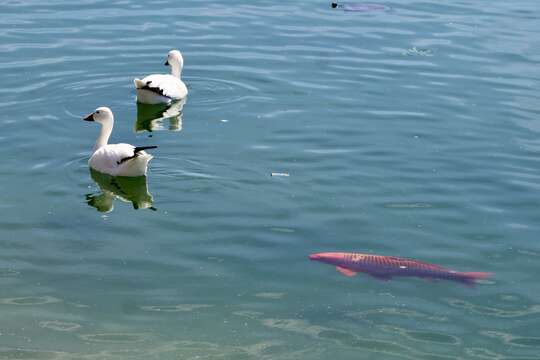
<box><xmin>86</xmin><ymin>169</ymin><xmax>155</xmax><ymax>212</ymax></box>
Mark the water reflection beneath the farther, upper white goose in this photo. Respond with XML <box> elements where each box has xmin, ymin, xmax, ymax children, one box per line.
<box><xmin>135</xmin><ymin>98</ymin><xmax>186</xmax><ymax>132</ymax></box>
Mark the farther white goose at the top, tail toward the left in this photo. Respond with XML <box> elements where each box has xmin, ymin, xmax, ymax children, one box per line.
<box><xmin>133</xmin><ymin>50</ymin><xmax>188</xmax><ymax>104</ymax></box>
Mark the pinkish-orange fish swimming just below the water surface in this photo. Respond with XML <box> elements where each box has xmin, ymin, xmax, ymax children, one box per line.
<box><xmin>309</xmin><ymin>252</ymin><xmax>491</xmax><ymax>285</ymax></box>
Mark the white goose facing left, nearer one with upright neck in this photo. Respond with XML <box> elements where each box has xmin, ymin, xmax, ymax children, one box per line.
<box><xmin>84</xmin><ymin>107</ymin><xmax>157</xmax><ymax>176</ymax></box>
